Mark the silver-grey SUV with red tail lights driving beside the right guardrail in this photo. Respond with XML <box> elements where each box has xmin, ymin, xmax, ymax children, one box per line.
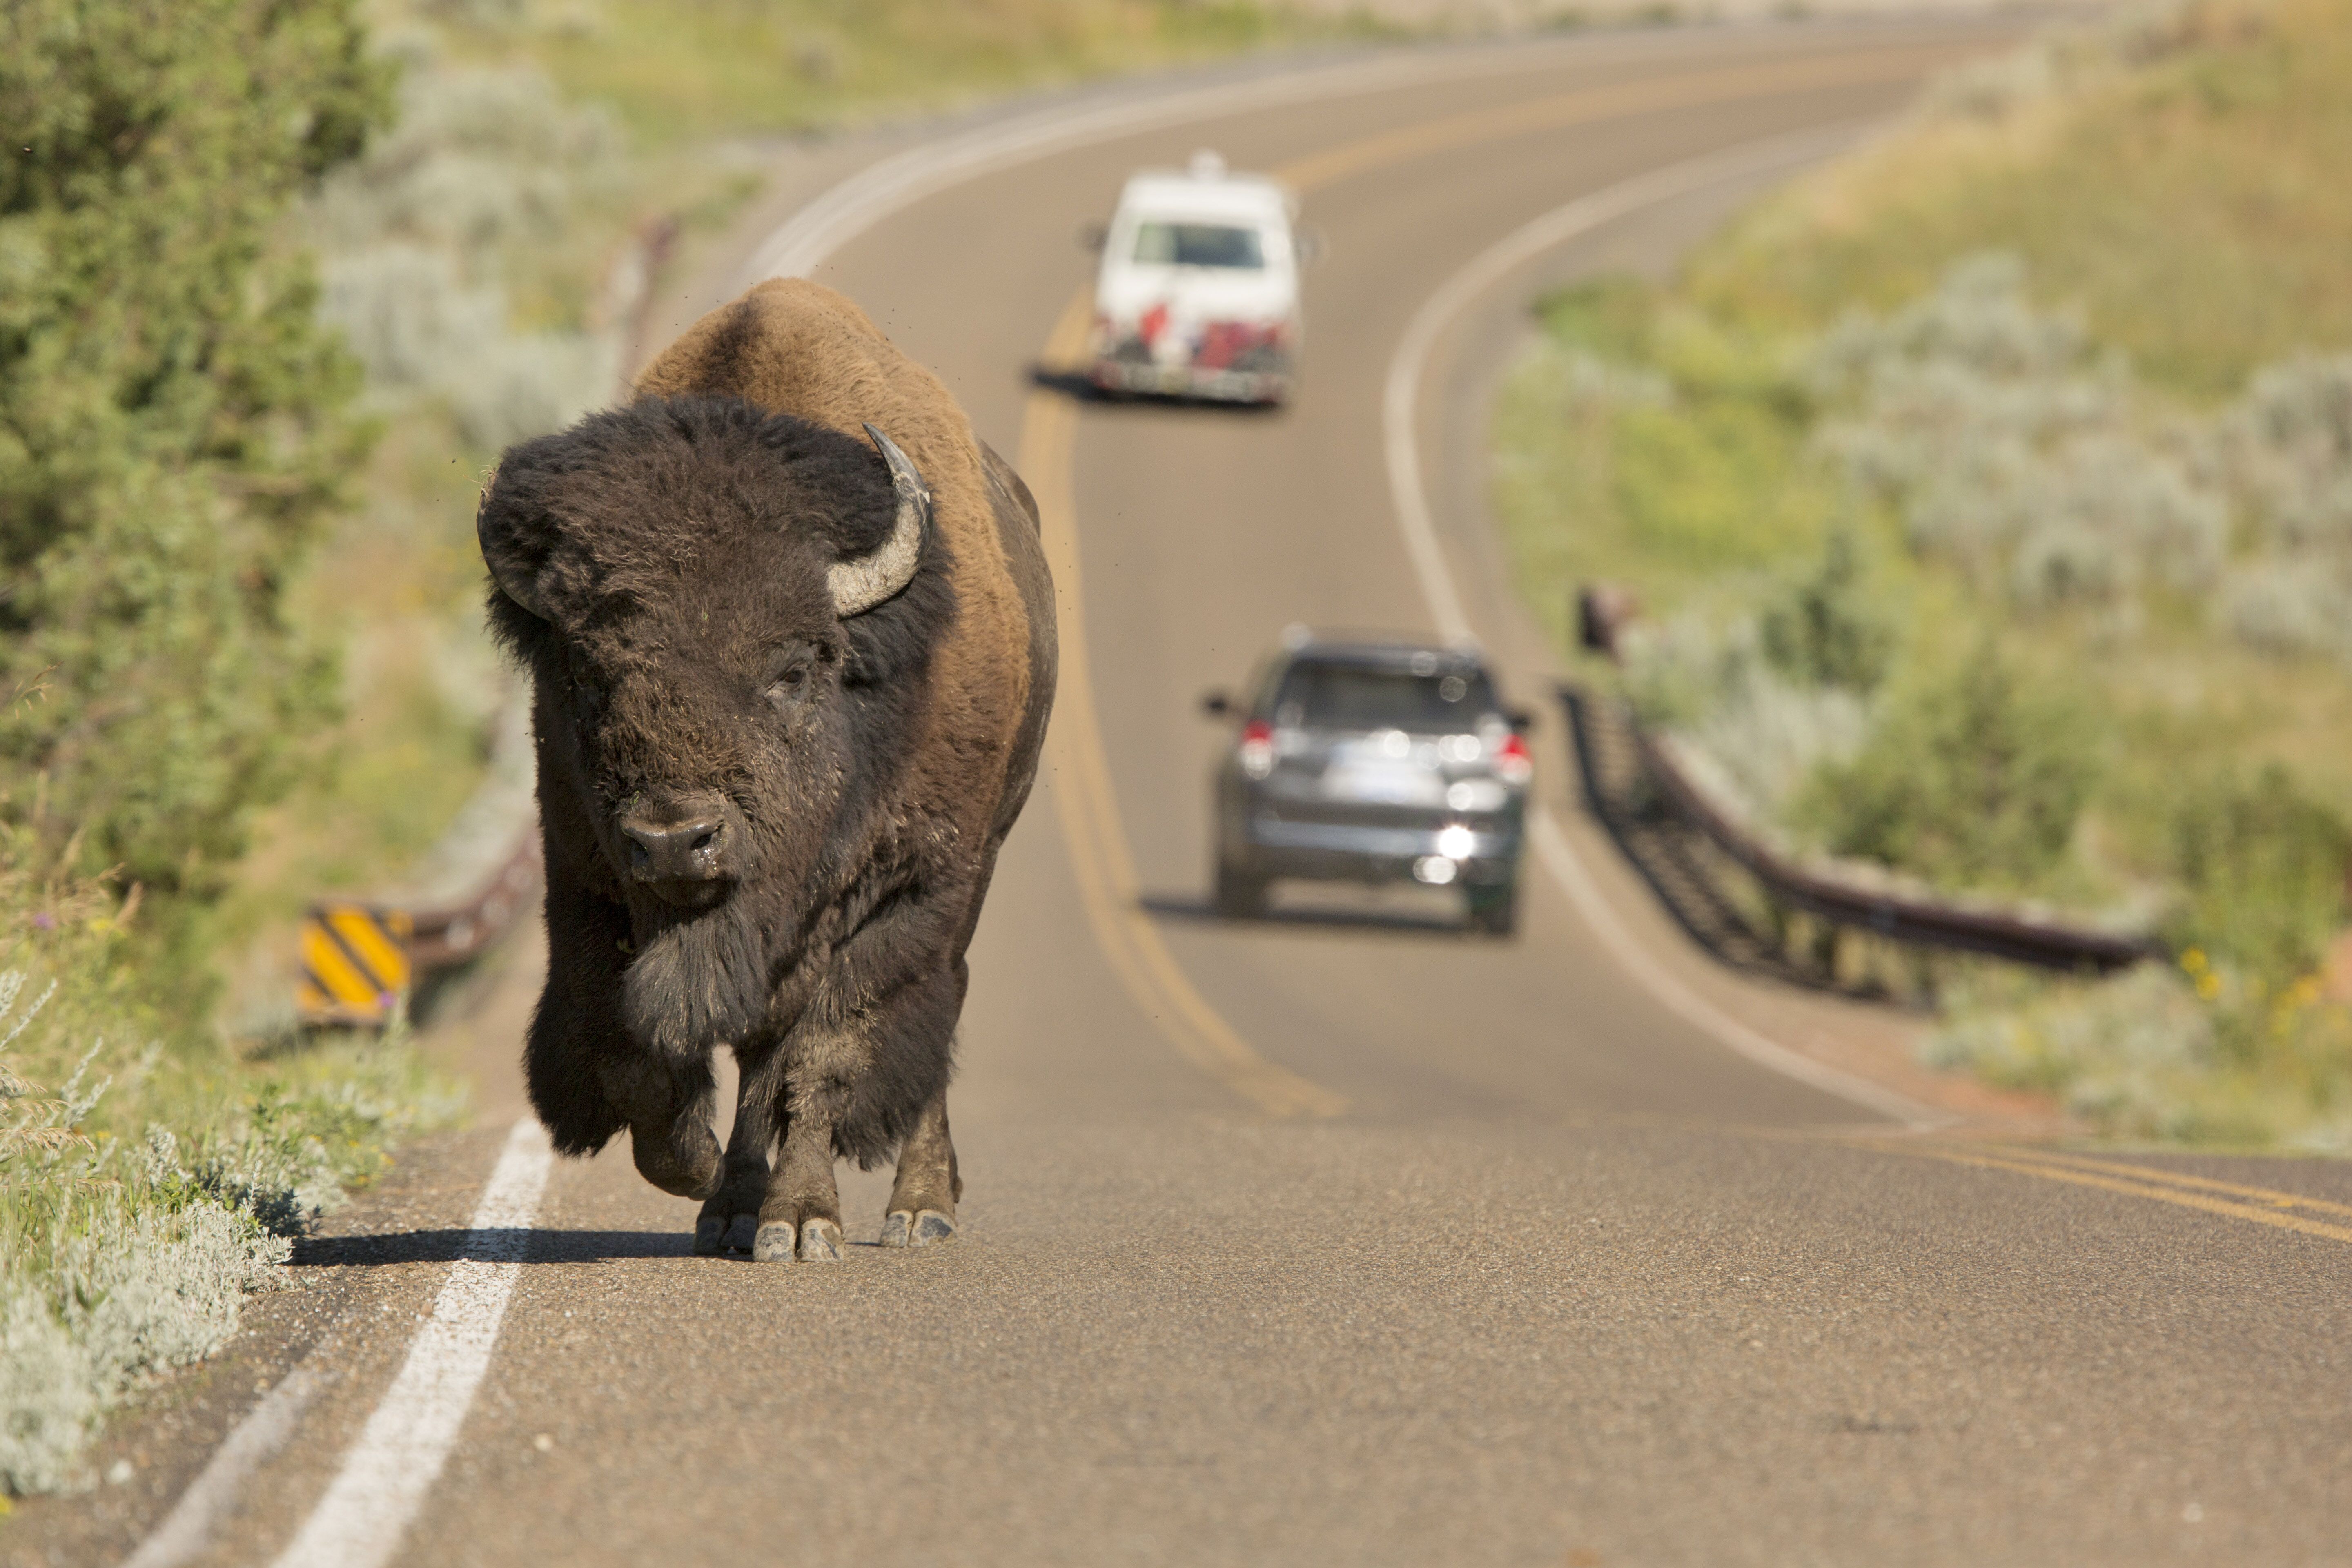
<box><xmin>1202</xmin><ymin>633</ymin><xmax>1534</xmax><ymax>935</ymax></box>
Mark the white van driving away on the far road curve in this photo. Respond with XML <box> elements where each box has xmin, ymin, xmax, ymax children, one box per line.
<box><xmin>1094</xmin><ymin>153</ymin><xmax>1301</xmax><ymax>402</ymax></box>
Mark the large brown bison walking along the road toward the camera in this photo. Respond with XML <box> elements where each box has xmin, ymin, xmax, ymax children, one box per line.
<box><xmin>475</xmin><ymin>280</ymin><xmax>1054</xmax><ymax>1260</ymax></box>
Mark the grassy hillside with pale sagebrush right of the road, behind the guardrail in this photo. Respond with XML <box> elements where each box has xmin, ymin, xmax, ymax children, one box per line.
<box><xmin>1496</xmin><ymin>0</ymin><xmax>2352</xmax><ymax>1145</ymax></box>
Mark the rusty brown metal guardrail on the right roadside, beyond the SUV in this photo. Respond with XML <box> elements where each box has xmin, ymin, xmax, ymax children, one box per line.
<box><xmin>1562</xmin><ymin>586</ymin><xmax>2164</xmax><ymax>971</ymax></box>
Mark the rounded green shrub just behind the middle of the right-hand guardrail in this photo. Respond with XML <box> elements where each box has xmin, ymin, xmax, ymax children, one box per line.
<box><xmin>1797</xmin><ymin>639</ymin><xmax>2100</xmax><ymax>889</ymax></box>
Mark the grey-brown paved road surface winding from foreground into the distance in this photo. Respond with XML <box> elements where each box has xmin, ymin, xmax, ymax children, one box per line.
<box><xmin>23</xmin><ymin>19</ymin><xmax>2352</xmax><ymax>1568</ymax></box>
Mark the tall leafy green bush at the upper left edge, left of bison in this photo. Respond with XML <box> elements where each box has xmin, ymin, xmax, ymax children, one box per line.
<box><xmin>0</xmin><ymin>0</ymin><xmax>383</xmax><ymax>893</ymax></box>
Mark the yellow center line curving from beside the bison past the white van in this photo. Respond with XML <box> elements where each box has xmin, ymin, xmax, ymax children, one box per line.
<box><xmin>1016</xmin><ymin>45</ymin><xmax>1955</xmax><ymax>1117</ymax></box>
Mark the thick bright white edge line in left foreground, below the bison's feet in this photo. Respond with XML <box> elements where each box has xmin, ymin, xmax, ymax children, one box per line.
<box><xmin>278</xmin><ymin>1117</ymin><xmax>555</xmax><ymax>1568</ymax></box>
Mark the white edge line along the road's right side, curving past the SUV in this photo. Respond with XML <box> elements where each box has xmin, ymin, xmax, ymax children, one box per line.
<box><xmin>1381</xmin><ymin>122</ymin><xmax>1955</xmax><ymax>1131</ymax></box>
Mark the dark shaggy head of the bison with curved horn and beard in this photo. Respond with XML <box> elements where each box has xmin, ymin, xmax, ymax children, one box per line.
<box><xmin>475</xmin><ymin>400</ymin><xmax>953</xmax><ymax>1051</ymax></box>
